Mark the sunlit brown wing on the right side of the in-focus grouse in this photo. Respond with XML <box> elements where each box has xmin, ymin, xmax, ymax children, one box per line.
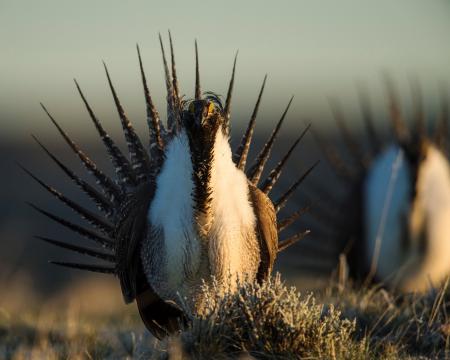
<box><xmin>249</xmin><ymin>183</ymin><xmax>278</xmax><ymax>282</ymax></box>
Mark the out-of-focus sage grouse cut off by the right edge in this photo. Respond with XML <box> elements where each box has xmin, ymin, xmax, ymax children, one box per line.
<box><xmin>311</xmin><ymin>78</ymin><xmax>450</xmax><ymax>292</ymax></box>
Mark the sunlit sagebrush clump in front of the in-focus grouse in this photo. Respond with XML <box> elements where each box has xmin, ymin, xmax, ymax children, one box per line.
<box><xmin>179</xmin><ymin>276</ymin><xmax>367</xmax><ymax>359</ymax></box>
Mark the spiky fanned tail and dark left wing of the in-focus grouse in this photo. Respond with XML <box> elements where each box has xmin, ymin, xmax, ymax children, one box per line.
<box><xmin>29</xmin><ymin>36</ymin><xmax>317</xmax><ymax>336</ymax></box>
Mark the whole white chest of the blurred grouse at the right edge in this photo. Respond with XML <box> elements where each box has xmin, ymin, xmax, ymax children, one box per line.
<box><xmin>365</xmin><ymin>146</ymin><xmax>450</xmax><ymax>291</ymax></box>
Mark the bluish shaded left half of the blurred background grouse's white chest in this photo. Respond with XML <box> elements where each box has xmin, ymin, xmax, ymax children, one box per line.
<box><xmin>363</xmin><ymin>146</ymin><xmax>412</xmax><ymax>280</ymax></box>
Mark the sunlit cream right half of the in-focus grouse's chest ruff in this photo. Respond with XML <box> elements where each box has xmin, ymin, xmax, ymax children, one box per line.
<box><xmin>209</xmin><ymin>133</ymin><xmax>259</xmax><ymax>282</ymax></box>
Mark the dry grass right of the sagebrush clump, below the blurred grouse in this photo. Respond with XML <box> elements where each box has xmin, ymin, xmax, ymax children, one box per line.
<box><xmin>324</xmin><ymin>280</ymin><xmax>450</xmax><ymax>359</ymax></box>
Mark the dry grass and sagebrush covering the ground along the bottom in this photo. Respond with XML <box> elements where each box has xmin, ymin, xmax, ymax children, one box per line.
<box><xmin>0</xmin><ymin>276</ymin><xmax>450</xmax><ymax>359</ymax></box>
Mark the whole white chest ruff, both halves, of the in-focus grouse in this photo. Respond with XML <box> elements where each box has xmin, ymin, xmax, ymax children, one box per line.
<box><xmin>144</xmin><ymin>132</ymin><xmax>259</xmax><ymax>297</ymax></box>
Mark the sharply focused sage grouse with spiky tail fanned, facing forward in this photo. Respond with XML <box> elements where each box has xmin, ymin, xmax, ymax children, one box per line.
<box><xmin>22</xmin><ymin>33</ymin><xmax>312</xmax><ymax>337</ymax></box>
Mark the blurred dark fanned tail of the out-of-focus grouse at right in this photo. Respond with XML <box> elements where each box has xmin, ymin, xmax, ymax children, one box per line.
<box><xmin>300</xmin><ymin>79</ymin><xmax>449</xmax><ymax>279</ymax></box>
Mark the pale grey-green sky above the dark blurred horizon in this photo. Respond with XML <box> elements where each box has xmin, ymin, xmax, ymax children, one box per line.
<box><xmin>0</xmin><ymin>0</ymin><xmax>450</xmax><ymax>138</ymax></box>
